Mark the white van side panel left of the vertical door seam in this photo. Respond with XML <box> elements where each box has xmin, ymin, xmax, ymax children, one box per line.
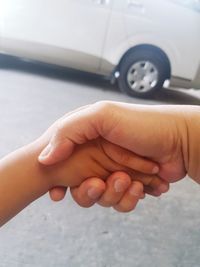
<box><xmin>0</xmin><ymin>0</ymin><xmax>112</xmax><ymax>71</ymax></box>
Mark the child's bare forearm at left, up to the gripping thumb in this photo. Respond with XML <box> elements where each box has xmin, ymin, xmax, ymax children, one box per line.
<box><xmin>0</xmin><ymin>141</ymin><xmax>51</xmax><ymax>226</ymax></box>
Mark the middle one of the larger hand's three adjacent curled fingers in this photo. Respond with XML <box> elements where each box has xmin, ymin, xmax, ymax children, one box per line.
<box><xmin>98</xmin><ymin>172</ymin><xmax>131</xmax><ymax>207</ymax></box>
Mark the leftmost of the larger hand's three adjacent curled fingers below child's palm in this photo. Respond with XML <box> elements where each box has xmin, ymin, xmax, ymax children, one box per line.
<box><xmin>71</xmin><ymin>177</ymin><xmax>106</xmax><ymax>208</ymax></box>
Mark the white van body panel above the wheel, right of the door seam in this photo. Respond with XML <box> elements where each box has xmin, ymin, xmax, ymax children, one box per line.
<box><xmin>111</xmin><ymin>0</ymin><xmax>200</xmax><ymax>86</ymax></box>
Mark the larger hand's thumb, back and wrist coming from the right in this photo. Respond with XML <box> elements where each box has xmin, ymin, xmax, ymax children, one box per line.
<box><xmin>39</xmin><ymin>101</ymin><xmax>200</xmax><ymax>211</ymax></box>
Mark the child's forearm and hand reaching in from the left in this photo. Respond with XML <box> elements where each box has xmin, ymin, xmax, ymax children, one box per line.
<box><xmin>0</xmin><ymin>134</ymin><xmax>166</xmax><ymax>226</ymax></box>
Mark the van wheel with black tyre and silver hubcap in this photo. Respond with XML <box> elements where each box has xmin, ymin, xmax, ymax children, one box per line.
<box><xmin>118</xmin><ymin>50</ymin><xmax>167</xmax><ymax>98</ymax></box>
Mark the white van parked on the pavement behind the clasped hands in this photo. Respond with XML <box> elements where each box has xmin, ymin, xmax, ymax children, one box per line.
<box><xmin>0</xmin><ymin>0</ymin><xmax>200</xmax><ymax>97</ymax></box>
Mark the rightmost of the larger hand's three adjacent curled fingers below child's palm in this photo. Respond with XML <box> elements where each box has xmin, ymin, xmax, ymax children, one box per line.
<box><xmin>114</xmin><ymin>181</ymin><xmax>143</xmax><ymax>212</ymax></box>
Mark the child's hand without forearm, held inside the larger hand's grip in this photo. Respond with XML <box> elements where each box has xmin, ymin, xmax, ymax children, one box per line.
<box><xmin>47</xmin><ymin>139</ymin><xmax>168</xmax><ymax>200</ymax></box>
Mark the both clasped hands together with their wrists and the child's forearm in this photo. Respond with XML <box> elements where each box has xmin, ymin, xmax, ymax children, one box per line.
<box><xmin>3</xmin><ymin>101</ymin><xmax>200</xmax><ymax>226</ymax></box>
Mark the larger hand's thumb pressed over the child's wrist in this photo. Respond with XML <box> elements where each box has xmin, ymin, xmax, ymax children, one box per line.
<box><xmin>38</xmin><ymin>105</ymin><xmax>103</xmax><ymax>165</ymax></box>
